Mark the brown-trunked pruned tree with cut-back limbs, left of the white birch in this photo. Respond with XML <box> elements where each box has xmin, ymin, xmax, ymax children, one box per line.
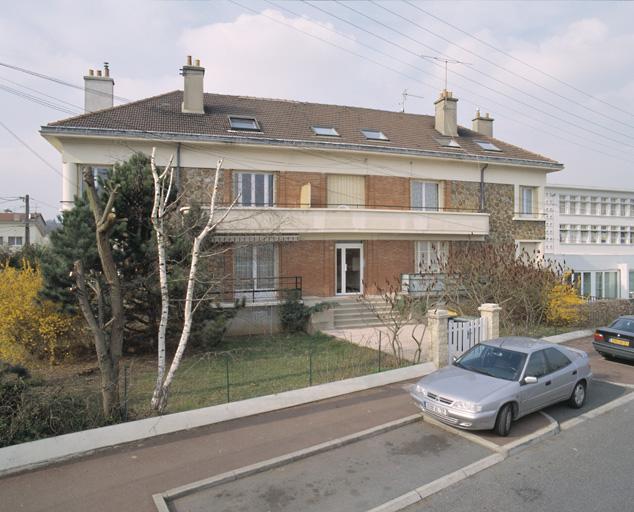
<box><xmin>72</xmin><ymin>168</ymin><xmax>125</xmax><ymax>418</ymax></box>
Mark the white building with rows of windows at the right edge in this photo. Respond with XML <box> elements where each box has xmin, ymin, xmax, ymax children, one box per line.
<box><xmin>544</xmin><ymin>185</ymin><xmax>634</xmax><ymax>299</ymax></box>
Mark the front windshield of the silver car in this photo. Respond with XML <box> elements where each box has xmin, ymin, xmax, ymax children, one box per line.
<box><xmin>454</xmin><ymin>343</ymin><xmax>526</xmax><ymax>380</ymax></box>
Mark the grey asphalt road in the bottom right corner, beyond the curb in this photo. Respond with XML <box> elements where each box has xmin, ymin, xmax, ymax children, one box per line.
<box><xmin>407</xmin><ymin>402</ymin><xmax>634</xmax><ymax>512</ymax></box>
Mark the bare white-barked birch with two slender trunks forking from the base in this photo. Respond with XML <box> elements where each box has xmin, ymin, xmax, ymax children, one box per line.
<box><xmin>150</xmin><ymin>149</ymin><xmax>238</xmax><ymax>413</ymax></box>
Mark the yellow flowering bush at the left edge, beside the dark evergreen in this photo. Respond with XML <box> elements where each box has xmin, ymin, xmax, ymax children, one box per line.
<box><xmin>0</xmin><ymin>262</ymin><xmax>81</xmax><ymax>364</ymax></box>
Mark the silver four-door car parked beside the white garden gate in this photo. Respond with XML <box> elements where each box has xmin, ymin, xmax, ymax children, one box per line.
<box><xmin>411</xmin><ymin>337</ymin><xmax>592</xmax><ymax>436</ymax></box>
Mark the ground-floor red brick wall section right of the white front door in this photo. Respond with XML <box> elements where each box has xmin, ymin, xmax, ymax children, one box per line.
<box><xmin>363</xmin><ymin>240</ymin><xmax>415</xmax><ymax>294</ymax></box>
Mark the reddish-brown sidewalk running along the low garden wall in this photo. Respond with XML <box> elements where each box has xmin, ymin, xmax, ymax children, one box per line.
<box><xmin>0</xmin><ymin>383</ymin><xmax>418</xmax><ymax>512</ymax></box>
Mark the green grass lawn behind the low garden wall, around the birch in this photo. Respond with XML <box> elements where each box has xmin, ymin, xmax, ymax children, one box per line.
<box><xmin>122</xmin><ymin>343</ymin><xmax>412</xmax><ymax>416</ymax></box>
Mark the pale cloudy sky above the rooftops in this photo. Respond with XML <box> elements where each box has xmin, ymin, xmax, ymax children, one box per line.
<box><xmin>0</xmin><ymin>0</ymin><xmax>634</xmax><ymax>218</ymax></box>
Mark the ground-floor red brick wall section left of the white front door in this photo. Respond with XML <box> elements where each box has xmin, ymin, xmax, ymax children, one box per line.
<box><xmin>279</xmin><ymin>240</ymin><xmax>335</xmax><ymax>297</ymax></box>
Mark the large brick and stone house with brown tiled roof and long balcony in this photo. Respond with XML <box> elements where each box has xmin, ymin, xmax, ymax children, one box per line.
<box><xmin>41</xmin><ymin>58</ymin><xmax>563</xmax><ymax>330</ymax></box>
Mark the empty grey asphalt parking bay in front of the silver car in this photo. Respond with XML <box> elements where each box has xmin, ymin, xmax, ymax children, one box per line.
<box><xmin>170</xmin><ymin>421</ymin><xmax>491</xmax><ymax>512</ymax></box>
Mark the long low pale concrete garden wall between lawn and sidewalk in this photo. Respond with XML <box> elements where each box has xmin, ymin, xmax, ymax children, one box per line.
<box><xmin>0</xmin><ymin>363</ymin><xmax>436</xmax><ymax>476</ymax></box>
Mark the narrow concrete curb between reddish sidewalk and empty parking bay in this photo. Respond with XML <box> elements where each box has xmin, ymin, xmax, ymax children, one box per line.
<box><xmin>152</xmin><ymin>413</ymin><xmax>422</xmax><ymax>512</ymax></box>
